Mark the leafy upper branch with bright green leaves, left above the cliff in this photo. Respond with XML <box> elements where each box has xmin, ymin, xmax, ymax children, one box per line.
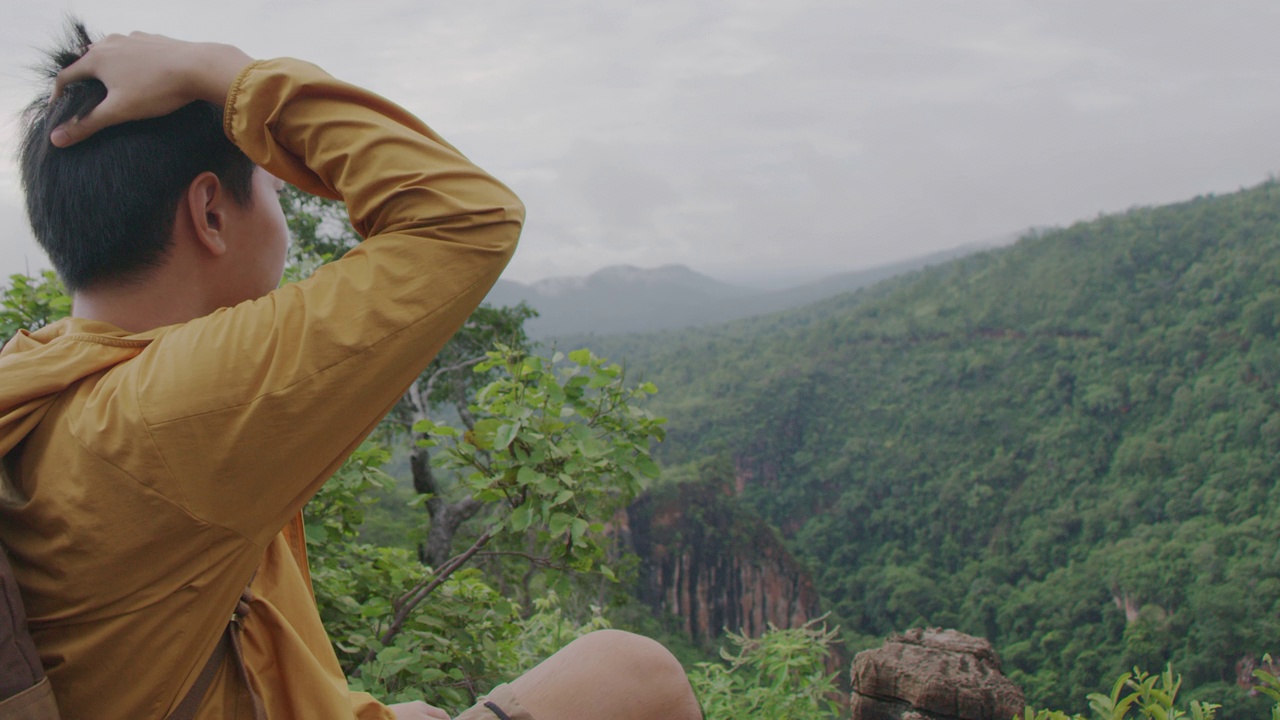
<box><xmin>346</xmin><ymin>346</ymin><xmax>663</xmax><ymax>676</ymax></box>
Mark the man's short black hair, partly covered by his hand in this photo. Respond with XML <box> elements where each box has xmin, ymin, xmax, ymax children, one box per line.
<box><xmin>19</xmin><ymin>19</ymin><xmax>253</xmax><ymax>292</ymax></box>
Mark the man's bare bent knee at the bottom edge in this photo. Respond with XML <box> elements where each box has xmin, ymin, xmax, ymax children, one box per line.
<box><xmin>499</xmin><ymin>630</ymin><xmax>703</xmax><ymax>720</ymax></box>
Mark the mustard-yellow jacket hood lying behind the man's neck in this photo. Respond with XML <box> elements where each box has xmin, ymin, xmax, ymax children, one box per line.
<box><xmin>0</xmin><ymin>318</ymin><xmax>151</xmax><ymax>456</ymax></box>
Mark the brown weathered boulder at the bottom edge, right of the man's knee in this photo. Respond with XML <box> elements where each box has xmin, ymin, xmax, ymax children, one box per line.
<box><xmin>851</xmin><ymin>628</ymin><xmax>1025</xmax><ymax>720</ymax></box>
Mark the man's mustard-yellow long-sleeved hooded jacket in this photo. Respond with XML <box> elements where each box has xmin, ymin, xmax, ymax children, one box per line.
<box><xmin>0</xmin><ymin>59</ymin><xmax>524</xmax><ymax>720</ymax></box>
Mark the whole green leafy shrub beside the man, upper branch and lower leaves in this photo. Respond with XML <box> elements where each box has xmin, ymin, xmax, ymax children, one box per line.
<box><xmin>307</xmin><ymin>348</ymin><xmax>660</xmax><ymax>708</ymax></box>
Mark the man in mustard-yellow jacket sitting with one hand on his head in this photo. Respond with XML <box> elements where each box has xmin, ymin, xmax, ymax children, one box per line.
<box><xmin>0</xmin><ymin>23</ymin><xmax>699</xmax><ymax>720</ymax></box>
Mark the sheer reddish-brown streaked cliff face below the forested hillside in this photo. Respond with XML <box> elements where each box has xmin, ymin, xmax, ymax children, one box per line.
<box><xmin>625</xmin><ymin>480</ymin><xmax>820</xmax><ymax>642</ymax></box>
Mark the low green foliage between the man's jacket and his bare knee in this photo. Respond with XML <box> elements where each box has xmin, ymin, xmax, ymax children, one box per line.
<box><xmin>307</xmin><ymin>442</ymin><xmax>608</xmax><ymax>710</ymax></box>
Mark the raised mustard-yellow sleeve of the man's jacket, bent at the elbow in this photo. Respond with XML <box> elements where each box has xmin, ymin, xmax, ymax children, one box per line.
<box><xmin>118</xmin><ymin>59</ymin><xmax>524</xmax><ymax>547</ymax></box>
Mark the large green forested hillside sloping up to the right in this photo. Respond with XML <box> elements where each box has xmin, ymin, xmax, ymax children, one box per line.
<box><xmin>593</xmin><ymin>182</ymin><xmax>1280</xmax><ymax>717</ymax></box>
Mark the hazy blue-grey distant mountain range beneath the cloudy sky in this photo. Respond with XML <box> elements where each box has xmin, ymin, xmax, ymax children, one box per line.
<box><xmin>485</xmin><ymin>245</ymin><xmax>989</xmax><ymax>340</ymax></box>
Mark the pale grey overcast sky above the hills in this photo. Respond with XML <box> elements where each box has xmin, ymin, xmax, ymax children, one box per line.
<box><xmin>0</xmin><ymin>0</ymin><xmax>1280</xmax><ymax>282</ymax></box>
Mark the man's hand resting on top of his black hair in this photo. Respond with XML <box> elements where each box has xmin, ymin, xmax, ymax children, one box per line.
<box><xmin>49</xmin><ymin>32</ymin><xmax>253</xmax><ymax>147</ymax></box>
